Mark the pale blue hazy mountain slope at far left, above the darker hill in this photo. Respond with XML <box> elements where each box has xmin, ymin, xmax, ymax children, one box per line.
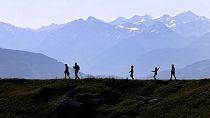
<box><xmin>0</xmin><ymin>22</ymin><xmax>47</xmax><ymax>51</ymax></box>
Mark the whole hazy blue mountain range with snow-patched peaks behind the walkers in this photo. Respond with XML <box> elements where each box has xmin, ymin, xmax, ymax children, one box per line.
<box><xmin>0</xmin><ymin>11</ymin><xmax>210</xmax><ymax>78</ymax></box>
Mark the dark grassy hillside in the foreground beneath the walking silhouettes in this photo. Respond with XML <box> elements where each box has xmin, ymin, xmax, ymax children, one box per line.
<box><xmin>0</xmin><ymin>79</ymin><xmax>210</xmax><ymax>118</ymax></box>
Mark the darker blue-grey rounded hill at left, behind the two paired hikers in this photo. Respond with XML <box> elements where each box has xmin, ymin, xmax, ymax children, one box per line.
<box><xmin>0</xmin><ymin>49</ymin><xmax>79</xmax><ymax>79</ymax></box>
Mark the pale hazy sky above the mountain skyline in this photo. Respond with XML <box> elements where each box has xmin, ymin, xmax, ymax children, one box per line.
<box><xmin>0</xmin><ymin>0</ymin><xmax>210</xmax><ymax>28</ymax></box>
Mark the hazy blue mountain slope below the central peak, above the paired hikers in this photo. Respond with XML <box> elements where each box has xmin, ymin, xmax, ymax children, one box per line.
<box><xmin>36</xmin><ymin>17</ymin><xmax>130</xmax><ymax>70</ymax></box>
